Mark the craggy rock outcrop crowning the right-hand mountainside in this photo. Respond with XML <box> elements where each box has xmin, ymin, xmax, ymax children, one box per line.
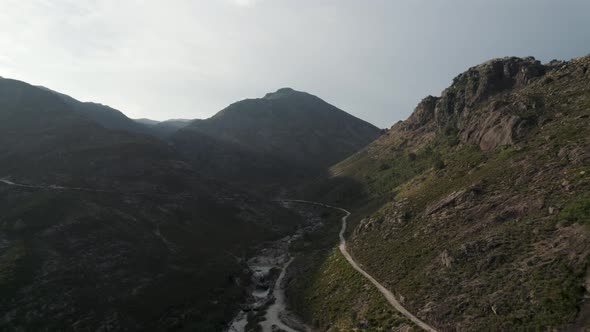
<box><xmin>401</xmin><ymin>57</ymin><xmax>547</xmax><ymax>150</ymax></box>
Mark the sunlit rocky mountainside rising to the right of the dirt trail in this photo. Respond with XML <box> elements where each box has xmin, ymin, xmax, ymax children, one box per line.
<box><xmin>301</xmin><ymin>56</ymin><xmax>590</xmax><ymax>331</ymax></box>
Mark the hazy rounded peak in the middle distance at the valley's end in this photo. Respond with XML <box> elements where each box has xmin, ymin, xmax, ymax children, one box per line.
<box><xmin>171</xmin><ymin>88</ymin><xmax>381</xmax><ymax>182</ymax></box>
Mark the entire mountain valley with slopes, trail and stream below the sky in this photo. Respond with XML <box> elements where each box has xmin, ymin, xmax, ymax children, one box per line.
<box><xmin>0</xmin><ymin>56</ymin><xmax>590</xmax><ymax>332</ymax></box>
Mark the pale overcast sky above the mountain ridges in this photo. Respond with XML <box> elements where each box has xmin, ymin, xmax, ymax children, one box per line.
<box><xmin>0</xmin><ymin>0</ymin><xmax>590</xmax><ymax>128</ymax></box>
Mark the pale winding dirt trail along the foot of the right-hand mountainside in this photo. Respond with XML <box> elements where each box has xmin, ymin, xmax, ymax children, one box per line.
<box><xmin>284</xmin><ymin>200</ymin><xmax>437</xmax><ymax>332</ymax></box>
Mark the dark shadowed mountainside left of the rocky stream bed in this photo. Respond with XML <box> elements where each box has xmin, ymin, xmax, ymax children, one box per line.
<box><xmin>0</xmin><ymin>79</ymin><xmax>306</xmax><ymax>331</ymax></box>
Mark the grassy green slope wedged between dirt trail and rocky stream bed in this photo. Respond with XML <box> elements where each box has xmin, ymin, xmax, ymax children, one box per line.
<box><xmin>287</xmin><ymin>209</ymin><xmax>411</xmax><ymax>331</ymax></box>
